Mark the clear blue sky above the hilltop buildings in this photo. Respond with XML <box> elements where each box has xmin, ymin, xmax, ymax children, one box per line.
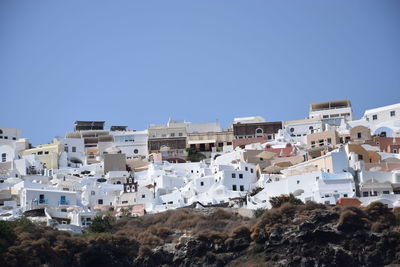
<box><xmin>0</xmin><ymin>0</ymin><xmax>400</xmax><ymax>145</ymax></box>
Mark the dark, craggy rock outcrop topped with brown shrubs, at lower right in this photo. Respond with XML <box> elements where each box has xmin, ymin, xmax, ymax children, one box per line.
<box><xmin>135</xmin><ymin>204</ymin><xmax>400</xmax><ymax>266</ymax></box>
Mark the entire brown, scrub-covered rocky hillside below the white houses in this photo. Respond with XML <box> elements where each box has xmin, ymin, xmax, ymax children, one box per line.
<box><xmin>0</xmin><ymin>202</ymin><xmax>400</xmax><ymax>266</ymax></box>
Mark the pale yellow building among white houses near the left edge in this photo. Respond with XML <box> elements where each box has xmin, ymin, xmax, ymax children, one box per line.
<box><xmin>21</xmin><ymin>138</ymin><xmax>64</xmax><ymax>169</ymax></box>
